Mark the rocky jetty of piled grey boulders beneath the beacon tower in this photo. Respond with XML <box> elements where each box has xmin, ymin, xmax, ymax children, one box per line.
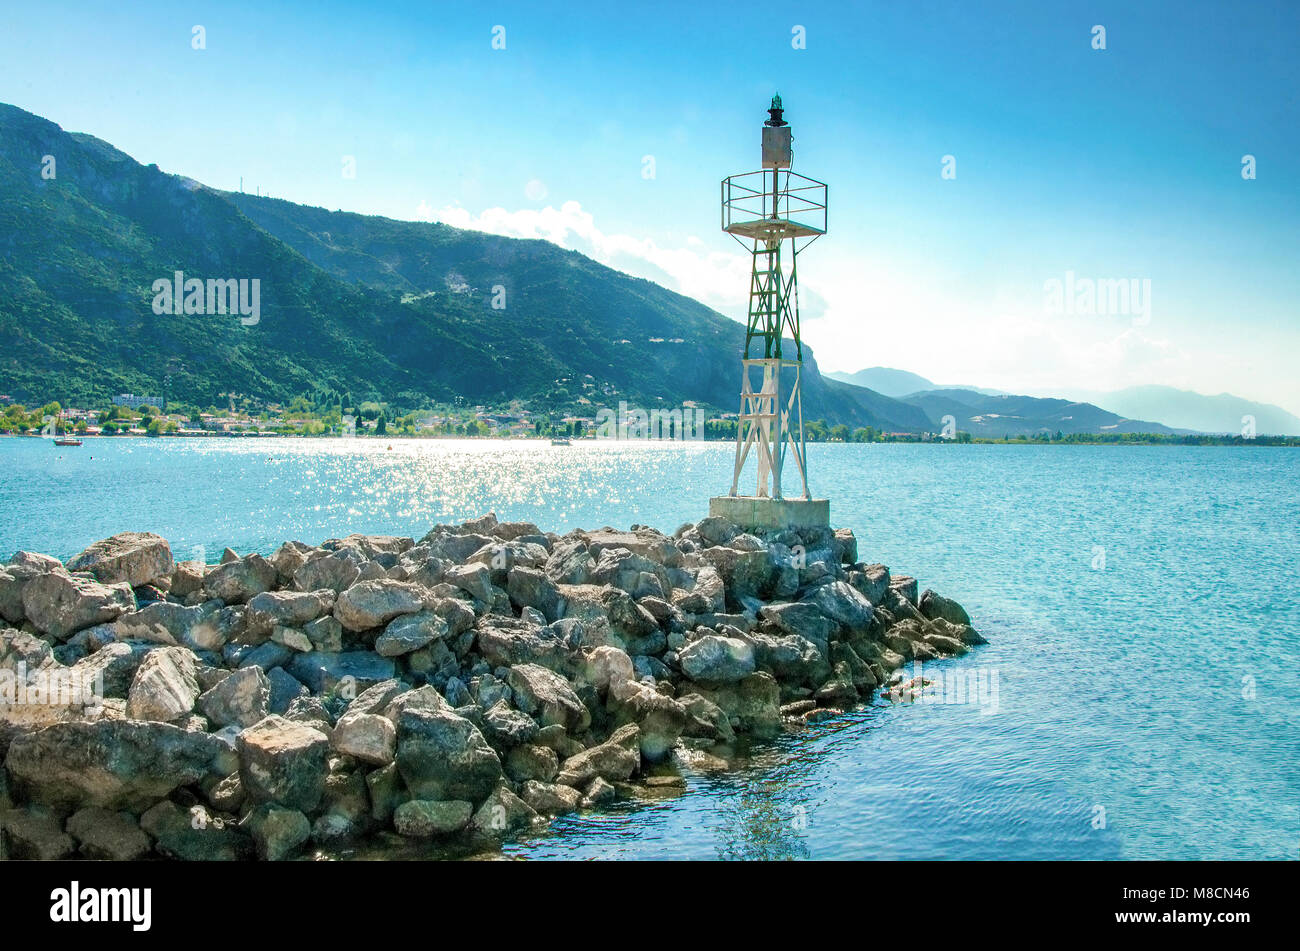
<box><xmin>0</xmin><ymin>514</ymin><xmax>983</xmax><ymax>859</ymax></box>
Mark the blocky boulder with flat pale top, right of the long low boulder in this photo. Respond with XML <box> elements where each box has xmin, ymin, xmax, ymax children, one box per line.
<box><xmin>235</xmin><ymin>713</ymin><xmax>329</xmax><ymax>813</ymax></box>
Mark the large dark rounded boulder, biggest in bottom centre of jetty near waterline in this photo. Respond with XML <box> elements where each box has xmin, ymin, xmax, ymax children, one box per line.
<box><xmin>397</xmin><ymin>709</ymin><xmax>502</xmax><ymax>803</ymax></box>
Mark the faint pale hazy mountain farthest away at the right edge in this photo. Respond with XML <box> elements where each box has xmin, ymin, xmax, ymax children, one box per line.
<box><xmin>1066</xmin><ymin>386</ymin><xmax>1300</xmax><ymax>435</ymax></box>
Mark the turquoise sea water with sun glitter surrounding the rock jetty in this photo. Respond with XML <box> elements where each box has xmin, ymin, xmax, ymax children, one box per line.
<box><xmin>0</xmin><ymin>439</ymin><xmax>1300</xmax><ymax>859</ymax></box>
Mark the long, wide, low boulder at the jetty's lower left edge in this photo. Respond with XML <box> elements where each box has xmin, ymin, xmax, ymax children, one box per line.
<box><xmin>5</xmin><ymin>720</ymin><xmax>233</xmax><ymax>812</ymax></box>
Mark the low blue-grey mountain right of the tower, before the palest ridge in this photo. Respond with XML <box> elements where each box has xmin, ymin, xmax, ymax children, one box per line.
<box><xmin>904</xmin><ymin>390</ymin><xmax>1174</xmax><ymax>438</ymax></box>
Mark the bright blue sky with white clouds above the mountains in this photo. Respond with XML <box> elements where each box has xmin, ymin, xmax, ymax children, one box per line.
<box><xmin>0</xmin><ymin>0</ymin><xmax>1300</xmax><ymax>413</ymax></box>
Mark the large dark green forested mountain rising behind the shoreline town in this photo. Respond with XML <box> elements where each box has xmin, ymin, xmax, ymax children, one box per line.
<box><xmin>0</xmin><ymin>104</ymin><xmax>928</xmax><ymax>431</ymax></box>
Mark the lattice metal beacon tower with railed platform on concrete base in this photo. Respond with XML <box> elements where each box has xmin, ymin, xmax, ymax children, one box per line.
<box><xmin>722</xmin><ymin>95</ymin><xmax>827</xmax><ymax>499</ymax></box>
